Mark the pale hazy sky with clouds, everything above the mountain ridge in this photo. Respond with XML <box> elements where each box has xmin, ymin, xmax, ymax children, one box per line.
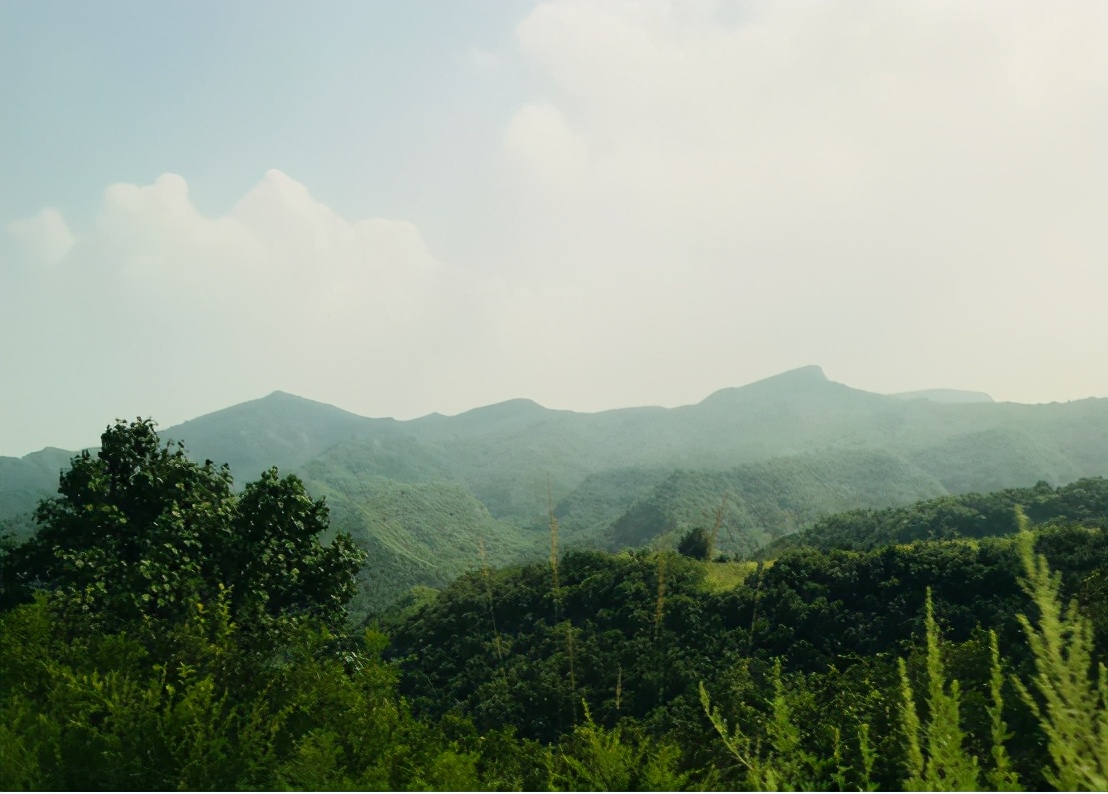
<box><xmin>0</xmin><ymin>0</ymin><xmax>1108</xmax><ymax>455</ymax></box>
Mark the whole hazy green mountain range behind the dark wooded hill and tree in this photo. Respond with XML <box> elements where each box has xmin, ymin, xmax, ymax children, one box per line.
<box><xmin>0</xmin><ymin>367</ymin><xmax>1108</xmax><ymax>605</ymax></box>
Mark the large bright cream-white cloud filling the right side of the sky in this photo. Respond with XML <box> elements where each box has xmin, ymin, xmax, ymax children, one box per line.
<box><xmin>504</xmin><ymin>0</ymin><xmax>1108</xmax><ymax>403</ymax></box>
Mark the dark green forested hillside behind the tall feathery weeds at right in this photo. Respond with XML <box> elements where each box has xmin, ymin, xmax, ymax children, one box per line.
<box><xmin>390</xmin><ymin>529</ymin><xmax>1108</xmax><ymax>788</ymax></box>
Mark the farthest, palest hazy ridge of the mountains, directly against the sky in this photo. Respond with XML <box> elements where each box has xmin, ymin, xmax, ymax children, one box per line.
<box><xmin>10</xmin><ymin>367</ymin><xmax>1108</xmax><ymax>524</ymax></box>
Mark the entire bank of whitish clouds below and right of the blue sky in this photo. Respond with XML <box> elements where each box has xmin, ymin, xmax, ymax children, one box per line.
<box><xmin>0</xmin><ymin>0</ymin><xmax>1108</xmax><ymax>454</ymax></box>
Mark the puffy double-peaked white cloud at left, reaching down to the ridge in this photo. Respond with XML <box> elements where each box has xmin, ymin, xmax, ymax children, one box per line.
<box><xmin>0</xmin><ymin>171</ymin><xmax>511</xmax><ymax>451</ymax></box>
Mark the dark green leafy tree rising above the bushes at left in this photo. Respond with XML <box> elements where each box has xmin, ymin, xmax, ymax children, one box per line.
<box><xmin>4</xmin><ymin>419</ymin><xmax>363</xmax><ymax>630</ymax></box>
